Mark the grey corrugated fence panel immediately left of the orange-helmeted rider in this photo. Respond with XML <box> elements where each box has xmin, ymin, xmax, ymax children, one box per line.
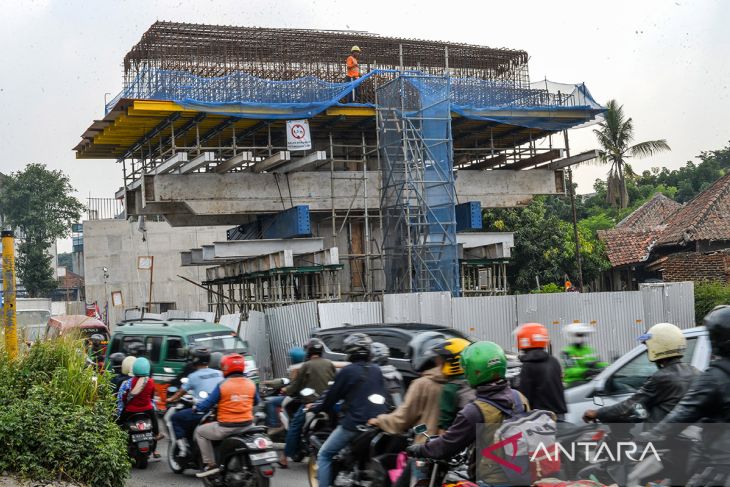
<box><xmin>451</xmin><ymin>296</ymin><xmax>517</xmax><ymax>350</ymax></box>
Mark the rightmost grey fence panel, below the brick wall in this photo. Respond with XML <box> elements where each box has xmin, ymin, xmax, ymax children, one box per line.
<box><xmin>639</xmin><ymin>281</ymin><xmax>696</xmax><ymax>328</ymax></box>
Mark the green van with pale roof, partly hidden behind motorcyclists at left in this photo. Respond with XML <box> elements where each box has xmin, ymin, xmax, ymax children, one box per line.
<box><xmin>106</xmin><ymin>319</ymin><xmax>258</xmax><ymax>409</ymax></box>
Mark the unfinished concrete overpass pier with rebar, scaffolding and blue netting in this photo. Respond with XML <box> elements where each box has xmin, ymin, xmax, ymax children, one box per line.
<box><xmin>74</xmin><ymin>22</ymin><xmax>604</xmax><ymax>317</ymax></box>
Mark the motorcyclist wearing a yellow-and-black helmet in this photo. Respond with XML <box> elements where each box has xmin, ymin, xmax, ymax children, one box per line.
<box><xmin>434</xmin><ymin>338</ymin><xmax>476</xmax><ymax>430</ymax></box>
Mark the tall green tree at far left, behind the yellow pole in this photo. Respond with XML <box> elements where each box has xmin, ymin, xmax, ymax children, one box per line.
<box><xmin>0</xmin><ymin>164</ymin><xmax>84</xmax><ymax>297</ymax></box>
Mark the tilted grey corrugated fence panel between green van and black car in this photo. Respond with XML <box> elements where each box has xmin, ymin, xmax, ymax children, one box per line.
<box><xmin>266</xmin><ymin>301</ymin><xmax>319</xmax><ymax>377</ymax></box>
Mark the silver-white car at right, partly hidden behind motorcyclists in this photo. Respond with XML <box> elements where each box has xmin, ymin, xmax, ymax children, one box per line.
<box><xmin>565</xmin><ymin>327</ymin><xmax>712</xmax><ymax>424</ymax></box>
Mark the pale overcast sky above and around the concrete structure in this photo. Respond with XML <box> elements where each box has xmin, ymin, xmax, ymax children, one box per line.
<box><xmin>0</xmin><ymin>0</ymin><xmax>730</xmax><ymax>250</ymax></box>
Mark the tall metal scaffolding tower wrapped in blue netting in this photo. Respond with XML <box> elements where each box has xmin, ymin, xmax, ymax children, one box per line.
<box><xmin>376</xmin><ymin>74</ymin><xmax>459</xmax><ymax>295</ymax></box>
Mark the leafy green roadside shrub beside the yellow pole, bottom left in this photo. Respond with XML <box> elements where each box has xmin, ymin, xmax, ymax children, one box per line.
<box><xmin>0</xmin><ymin>339</ymin><xmax>130</xmax><ymax>487</ymax></box>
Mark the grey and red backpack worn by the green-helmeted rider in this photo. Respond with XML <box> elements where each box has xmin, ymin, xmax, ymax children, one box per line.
<box><xmin>475</xmin><ymin>390</ymin><xmax>560</xmax><ymax>485</ymax></box>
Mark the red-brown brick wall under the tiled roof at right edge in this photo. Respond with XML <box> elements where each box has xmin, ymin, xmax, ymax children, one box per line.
<box><xmin>662</xmin><ymin>252</ymin><xmax>730</xmax><ymax>283</ymax></box>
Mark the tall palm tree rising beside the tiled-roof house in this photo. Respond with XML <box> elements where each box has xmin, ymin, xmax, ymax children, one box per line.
<box><xmin>593</xmin><ymin>100</ymin><xmax>671</xmax><ymax>208</ymax></box>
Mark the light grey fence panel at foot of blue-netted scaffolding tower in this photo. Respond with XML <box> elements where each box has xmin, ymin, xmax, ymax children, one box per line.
<box><xmin>383</xmin><ymin>292</ymin><xmax>451</xmax><ymax>326</ymax></box>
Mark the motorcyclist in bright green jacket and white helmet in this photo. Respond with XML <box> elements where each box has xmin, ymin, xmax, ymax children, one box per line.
<box><xmin>561</xmin><ymin>323</ymin><xmax>608</xmax><ymax>387</ymax></box>
